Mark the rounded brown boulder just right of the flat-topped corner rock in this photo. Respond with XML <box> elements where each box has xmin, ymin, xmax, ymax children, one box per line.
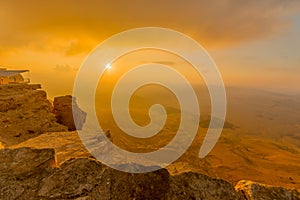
<box><xmin>37</xmin><ymin>158</ymin><xmax>104</xmax><ymax>199</ymax></box>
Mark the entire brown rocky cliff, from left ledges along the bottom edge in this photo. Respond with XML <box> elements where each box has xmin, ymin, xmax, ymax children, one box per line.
<box><xmin>0</xmin><ymin>84</ymin><xmax>300</xmax><ymax>200</ymax></box>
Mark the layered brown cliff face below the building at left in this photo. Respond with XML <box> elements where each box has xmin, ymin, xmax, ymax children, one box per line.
<box><xmin>0</xmin><ymin>84</ymin><xmax>67</xmax><ymax>146</ymax></box>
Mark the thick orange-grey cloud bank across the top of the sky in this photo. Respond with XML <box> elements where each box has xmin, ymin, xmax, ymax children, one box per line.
<box><xmin>0</xmin><ymin>0</ymin><xmax>300</xmax><ymax>56</ymax></box>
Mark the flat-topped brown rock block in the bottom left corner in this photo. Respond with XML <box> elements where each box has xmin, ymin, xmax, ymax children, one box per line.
<box><xmin>0</xmin><ymin>148</ymin><xmax>55</xmax><ymax>200</ymax></box>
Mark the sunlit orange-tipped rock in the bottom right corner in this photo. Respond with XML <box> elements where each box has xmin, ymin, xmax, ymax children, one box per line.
<box><xmin>235</xmin><ymin>180</ymin><xmax>300</xmax><ymax>200</ymax></box>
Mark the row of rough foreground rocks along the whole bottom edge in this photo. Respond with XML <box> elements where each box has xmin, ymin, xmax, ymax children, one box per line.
<box><xmin>0</xmin><ymin>147</ymin><xmax>300</xmax><ymax>200</ymax></box>
